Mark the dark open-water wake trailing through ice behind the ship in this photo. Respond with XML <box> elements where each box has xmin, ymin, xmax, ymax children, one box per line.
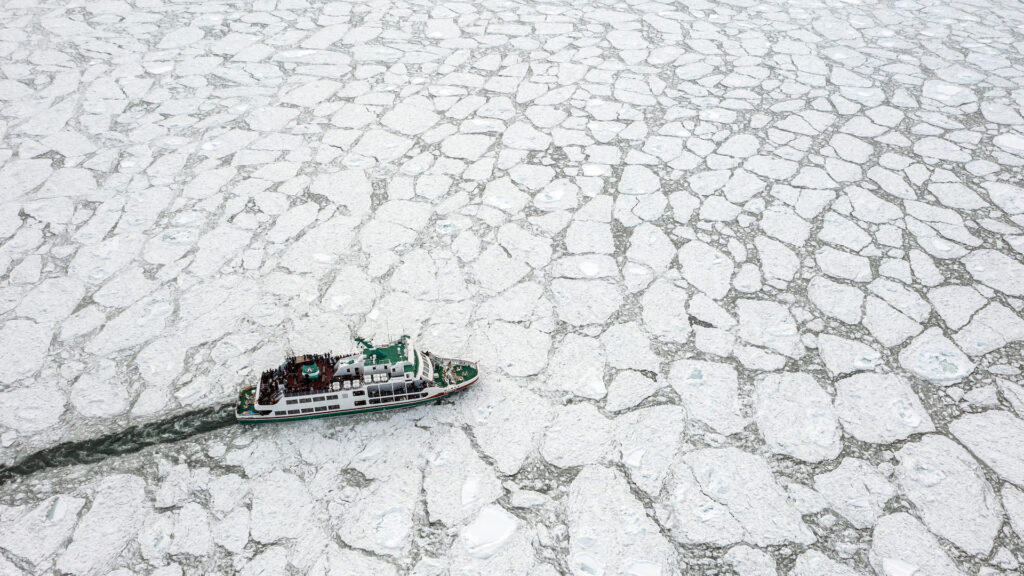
<box><xmin>0</xmin><ymin>403</ymin><xmax>236</xmax><ymax>485</ymax></box>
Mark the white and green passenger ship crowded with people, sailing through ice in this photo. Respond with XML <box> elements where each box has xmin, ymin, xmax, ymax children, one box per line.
<box><xmin>234</xmin><ymin>335</ymin><xmax>479</xmax><ymax>422</ymax></box>
